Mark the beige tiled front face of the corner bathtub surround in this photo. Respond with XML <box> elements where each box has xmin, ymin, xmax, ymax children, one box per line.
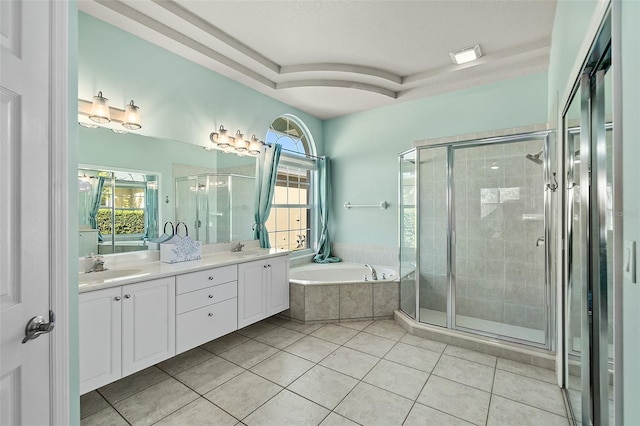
<box><xmin>289</xmin><ymin>281</ymin><xmax>400</xmax><ymax>324</ymax></box>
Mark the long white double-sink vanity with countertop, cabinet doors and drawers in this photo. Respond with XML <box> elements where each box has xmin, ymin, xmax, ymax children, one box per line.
<box><xmin>79</xmin><ymin>248</ymin><xmax>289</xmax><ymax>394</ymax></box>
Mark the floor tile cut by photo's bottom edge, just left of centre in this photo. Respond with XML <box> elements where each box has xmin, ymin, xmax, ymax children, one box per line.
<box><xmin>243</xmin><ymin>389</ymin><xmax>329</xmax><ymax>426</ymax></box>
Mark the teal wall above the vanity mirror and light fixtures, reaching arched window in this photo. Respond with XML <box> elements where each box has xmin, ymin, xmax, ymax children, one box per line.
<box><xmin>78</xmin><ymin>12</ymin><xmax>323</xmax><ymax>156</ymax></box>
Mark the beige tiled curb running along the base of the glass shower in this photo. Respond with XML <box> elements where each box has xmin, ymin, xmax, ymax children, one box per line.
<box><xmin>394</xmin><ymin>310</ymin><xmax>556</xmax><ymax>371</ymax></box>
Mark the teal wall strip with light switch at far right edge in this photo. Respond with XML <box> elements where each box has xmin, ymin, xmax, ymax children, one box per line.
<box><xmin>620</xmin><ymin>1</ymin><xmax>640</xmax><ymax>425</ymax></box>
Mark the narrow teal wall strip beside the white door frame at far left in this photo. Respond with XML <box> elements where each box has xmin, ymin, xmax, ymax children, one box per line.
<box><xmin>67</xmin><ymin>0</ymin><xmax>80</xmax><ymax>426</ymax></box>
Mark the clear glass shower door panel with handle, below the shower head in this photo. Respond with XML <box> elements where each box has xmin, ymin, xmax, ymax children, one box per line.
<box><xmin>452</xmin><ymin>138</ymin><xmax>549</xmax><ymax>346</ymax></box>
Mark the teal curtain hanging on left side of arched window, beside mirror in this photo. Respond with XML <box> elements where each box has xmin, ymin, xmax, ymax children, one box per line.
<box><xmin>253</xmin><ymin>144</ymin><xmax>282</xmax><ymax>248</ymax></box>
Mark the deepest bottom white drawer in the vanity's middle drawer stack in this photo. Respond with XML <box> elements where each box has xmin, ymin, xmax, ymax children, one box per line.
<box><xmin>176</xmin><ymin>298</ymin><xmax>238</xmax><ymax>354</ymax></box>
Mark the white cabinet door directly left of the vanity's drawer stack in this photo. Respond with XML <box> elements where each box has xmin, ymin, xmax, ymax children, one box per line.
<box><xmin>122</xmin><ymin>277</ymin><xmax>176</xmax><ymax>376</ymax></box>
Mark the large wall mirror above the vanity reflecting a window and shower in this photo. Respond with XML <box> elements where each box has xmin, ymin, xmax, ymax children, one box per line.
<box><xmin>78</xmin><ymin>126</ymin><xmax>256</xmax><ymax>257</ymax></box>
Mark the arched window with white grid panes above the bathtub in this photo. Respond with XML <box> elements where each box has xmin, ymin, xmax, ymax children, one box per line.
<box><xmin>265</xmin><ymin>115</ymin><xmax>317</xmax><ymax>251</ymax></box>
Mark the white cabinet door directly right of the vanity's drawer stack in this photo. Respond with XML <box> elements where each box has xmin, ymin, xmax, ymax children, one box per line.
<box><xmin>238</xmin><ymin>260</ymin><xmax>267</xmax><ymax>328</ymax></box>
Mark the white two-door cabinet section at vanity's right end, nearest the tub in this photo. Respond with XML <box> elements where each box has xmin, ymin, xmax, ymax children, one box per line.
<box><xmin>238</xmin><ymin>256</ymin><xmax>289</xmax><ymax>328</ymax></box>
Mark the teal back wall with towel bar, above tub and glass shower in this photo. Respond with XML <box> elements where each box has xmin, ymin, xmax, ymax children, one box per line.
<box><xmin>324</xmin><ymin>73</ymin><xmax>547</xmax><ymax>247</ymax></box>
